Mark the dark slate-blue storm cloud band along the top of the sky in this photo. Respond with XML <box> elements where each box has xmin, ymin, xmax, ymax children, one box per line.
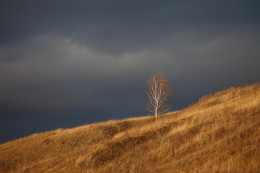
<box><xmin>0</xmin><ymin>0</ymin><xmax>260</xmax><ymax>53</ymax></box>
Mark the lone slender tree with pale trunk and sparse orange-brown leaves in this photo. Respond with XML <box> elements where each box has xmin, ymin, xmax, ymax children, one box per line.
<box><xmin>146</xmin><ymin>74</ymin><xmax>171</xmax><ymax>121</ymax></box>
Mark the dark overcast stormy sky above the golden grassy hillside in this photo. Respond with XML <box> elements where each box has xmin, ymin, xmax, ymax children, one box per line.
<box><xmin>0</xmin><ymin>0</ymin><xmax>260</xmax><ymax>143</ymax></box>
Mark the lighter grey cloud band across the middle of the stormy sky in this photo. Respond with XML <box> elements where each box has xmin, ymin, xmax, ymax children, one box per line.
<box><xmin>0</xmin><ymin>29</ymin><xmax>260</xmax><ymax>108</ymax></box>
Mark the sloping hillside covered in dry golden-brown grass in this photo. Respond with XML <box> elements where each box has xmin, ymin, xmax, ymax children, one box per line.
<box><xmin>0</xmin><ymin>84</ymin><xmax>260</xmax><ymax>173</ymax></box>
